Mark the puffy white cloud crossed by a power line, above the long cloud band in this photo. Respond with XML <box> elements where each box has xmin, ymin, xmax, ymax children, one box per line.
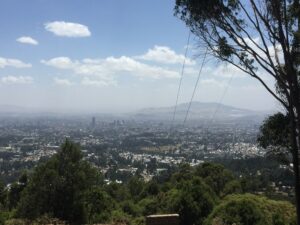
<box><xmin>135</xmin><ymin>45</ymin><xmax>196</xmax><ymax>65</ymax></box>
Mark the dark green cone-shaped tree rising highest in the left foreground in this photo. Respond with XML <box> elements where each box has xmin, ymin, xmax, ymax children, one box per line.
<box><xmin>17</xmin><ymin>140</ymin><xmax>99</xmax><ymax>224</ymax></box>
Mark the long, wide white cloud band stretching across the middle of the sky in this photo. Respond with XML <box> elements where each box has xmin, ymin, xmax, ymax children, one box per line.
<box><xmin>41</xmin><ymin>56</ymin><xmax>179</xmax><ymax>86</ymax></box>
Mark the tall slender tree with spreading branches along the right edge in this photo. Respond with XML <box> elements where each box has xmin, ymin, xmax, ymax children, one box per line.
<box><xmin>175</xmin><ymin>0</ymin><xmax>300</xmax><ymax>221</ymax></box>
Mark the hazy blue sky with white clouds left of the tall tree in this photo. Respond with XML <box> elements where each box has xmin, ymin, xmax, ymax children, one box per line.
<box><xmin>0</xmin><ymin>0</ymin><xmax>278</xmax><ymax>112</ymax></box>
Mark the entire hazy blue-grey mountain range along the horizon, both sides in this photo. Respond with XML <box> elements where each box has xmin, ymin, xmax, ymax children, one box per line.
<box><xmin>0</xmin><ymin>102</ymin><xmax>272</xmax><ymax>121</ymax></box>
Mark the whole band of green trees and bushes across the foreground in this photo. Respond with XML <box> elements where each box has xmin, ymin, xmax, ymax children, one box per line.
<box><xmin>0</xmin><ymin>140</ymin><xmax>296</xmax><ymax>225</ymax></box>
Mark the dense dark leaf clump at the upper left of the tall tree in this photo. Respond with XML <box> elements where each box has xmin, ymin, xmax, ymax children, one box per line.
<box><xmin>174</xmin><ymin>0</ymin><xmax>244</xmax><ymax>62</ymax></box>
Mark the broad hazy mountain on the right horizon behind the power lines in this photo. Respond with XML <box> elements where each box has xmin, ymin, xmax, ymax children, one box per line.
<box><xmin>134</xmin><ymin>102</ymin><xmax>272</xmax><ymax>121</ymax></box>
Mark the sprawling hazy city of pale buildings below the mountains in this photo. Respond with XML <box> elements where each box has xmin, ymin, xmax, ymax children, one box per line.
<box><xmin>0</xmin><ymin>117</ymin><xmax>264</xmax><ymax>183</ymax></box>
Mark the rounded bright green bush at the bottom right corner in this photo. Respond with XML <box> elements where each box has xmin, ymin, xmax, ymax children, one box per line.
<box><xmin>205</xmin><ymin>194</ymin><xmax>296</xmax><ymax>225</ymax></box>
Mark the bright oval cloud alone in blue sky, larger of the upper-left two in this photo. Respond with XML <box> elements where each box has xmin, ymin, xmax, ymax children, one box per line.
<box><xmin>45</xmin><ymin>21</ymin><xmax>91</xmax><ymax>37</ymax></box>
